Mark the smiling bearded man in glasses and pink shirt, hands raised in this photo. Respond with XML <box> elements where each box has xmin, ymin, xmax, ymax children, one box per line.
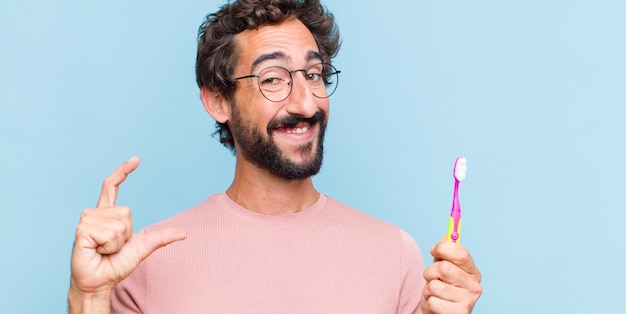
<box><xmin>68</xmin><ymin>0</ymin><xmax>481</xmax><ymax>314</ymax></box>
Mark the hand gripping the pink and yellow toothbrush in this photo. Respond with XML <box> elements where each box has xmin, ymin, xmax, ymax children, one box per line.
<box><xmin>422</xmin><ymin>237</ymin><xmax>482</xmax><ymax>314</ymax></box>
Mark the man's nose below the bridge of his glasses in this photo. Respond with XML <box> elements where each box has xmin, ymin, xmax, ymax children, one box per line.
<box><xmin>285</xmin><ymin>71</ymin><xmax>328</xmax><ymax>118</ymax></box>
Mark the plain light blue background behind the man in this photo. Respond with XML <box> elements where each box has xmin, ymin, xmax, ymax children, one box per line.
<box><xmin>0</xmin><ymin>0</ymin><xmax>626</xmax><ymax>313</ymax></box>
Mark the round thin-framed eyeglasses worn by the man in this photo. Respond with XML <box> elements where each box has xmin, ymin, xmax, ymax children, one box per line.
<box><xmin>234</xmin><ymin>63</ymin><xmax>341</xmax><ymax>102</ymax></box>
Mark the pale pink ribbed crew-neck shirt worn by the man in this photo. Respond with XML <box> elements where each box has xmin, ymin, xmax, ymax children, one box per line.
<box><xmin>111</xmin><ymin>193</ymin><xmax>424</xmax><ymax>314</ymax></box>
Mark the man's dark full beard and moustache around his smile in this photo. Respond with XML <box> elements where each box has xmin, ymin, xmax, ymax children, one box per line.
<box><xmin>229</xmin><ymin>104</ymin><xmax>327</xmax><ymax>180</ymax></box>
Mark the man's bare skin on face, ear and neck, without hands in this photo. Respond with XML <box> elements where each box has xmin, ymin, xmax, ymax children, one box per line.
<box><xmin>200</xmin><ymin>19</ymin><xmax>329</xmax><ymax>215</ymax></box>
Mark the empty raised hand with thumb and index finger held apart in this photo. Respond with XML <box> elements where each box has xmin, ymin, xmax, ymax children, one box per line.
<box><xmin>68</xmin><ymin>157</ymin><xmax>187</xmax><ymax>313</ymax></box>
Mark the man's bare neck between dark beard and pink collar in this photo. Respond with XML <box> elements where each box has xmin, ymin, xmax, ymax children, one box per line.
<box><xmin>226</xmin><ymin>160</ymin><xmax>319</xmax><ymax>215</ymax></box>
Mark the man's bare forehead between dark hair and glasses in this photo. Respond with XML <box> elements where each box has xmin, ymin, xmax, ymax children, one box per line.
<box><xmin>236</xmin><ymin>19</ymin><xmax>321</xmax><ymax>74</ymax></box>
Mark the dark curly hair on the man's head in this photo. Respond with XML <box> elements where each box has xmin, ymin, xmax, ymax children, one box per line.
<box><xmin>196</xmin><ymin>0</ymin><xmax>341</xmax><ymax>152</ymax></box>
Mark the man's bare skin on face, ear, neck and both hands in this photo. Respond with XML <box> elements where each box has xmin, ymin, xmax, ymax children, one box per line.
<box><xmin>68</xmin><ymin>19</ymin><xmax>481</xmax><ymax>313</ymax></box>
